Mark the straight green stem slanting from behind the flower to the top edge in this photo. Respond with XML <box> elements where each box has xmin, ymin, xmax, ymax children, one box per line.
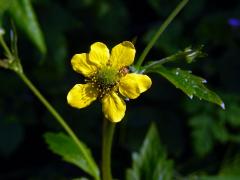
<box><xmin>136</xmin><ymin>0</ymin><xmax>188</xmax><ymax>69</ymax></box>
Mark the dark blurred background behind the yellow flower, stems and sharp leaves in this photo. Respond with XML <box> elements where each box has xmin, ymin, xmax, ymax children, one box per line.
<box><xmin>0</xmin><ymin>0</ymin><xmax>240</xmax><ymax>180</ymax></box>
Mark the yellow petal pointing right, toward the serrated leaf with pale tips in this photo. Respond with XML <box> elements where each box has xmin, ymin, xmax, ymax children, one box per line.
<box><xmin>119</xmin><ymin>73</ymin><xmax>152</xmax><ymax>99</ymax></box>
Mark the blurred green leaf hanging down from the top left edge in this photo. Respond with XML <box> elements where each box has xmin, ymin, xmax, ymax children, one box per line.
<box><xmin>9</xmin><ymin>0</ymin><xmax>47</xmax><ymax>54</ymax></box>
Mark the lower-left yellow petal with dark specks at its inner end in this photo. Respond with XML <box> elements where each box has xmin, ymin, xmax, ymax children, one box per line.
<box><xmin>67</xmin><ymin>84</ymin><xmax>97</xmax><ymax>109</ymax></box>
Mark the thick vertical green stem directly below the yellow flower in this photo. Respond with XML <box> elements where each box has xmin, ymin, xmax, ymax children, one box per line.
<box><xmin>102</xmin><ymin>118</ymin><xmax>115</xmax><ymax>180</ymax></box>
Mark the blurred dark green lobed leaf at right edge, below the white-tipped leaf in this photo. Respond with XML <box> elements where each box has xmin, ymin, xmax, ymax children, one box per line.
<box><xmin>186</xmin><ymin>94</ymin><xmax>240</xmax><ymax>157</ymax></box>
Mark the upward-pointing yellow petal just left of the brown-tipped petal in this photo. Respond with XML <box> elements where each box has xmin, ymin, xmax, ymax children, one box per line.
<box><xmin>89</xmin><ymin>42</ymin><xmax>110</xmax><ymax>68</ymax></box>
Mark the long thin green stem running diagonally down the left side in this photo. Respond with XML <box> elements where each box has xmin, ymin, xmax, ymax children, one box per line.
<box><xmin>17</xmin><ymin>72</ymin><xmax>99</xmax><ymax>180</ymax></box>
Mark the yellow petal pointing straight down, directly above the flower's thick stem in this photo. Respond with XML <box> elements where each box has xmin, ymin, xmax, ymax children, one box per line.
<box><xmin>102</xmin><ymin>92</ymin><xmax>126</xmax><ymax>123</ymax></box>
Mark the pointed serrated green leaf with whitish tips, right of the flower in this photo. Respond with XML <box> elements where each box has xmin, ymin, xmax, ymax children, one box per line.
<box><xmin>151</xmin><ymin>65</ymin><xmax>225</xmax><ymax>109</ymax></box>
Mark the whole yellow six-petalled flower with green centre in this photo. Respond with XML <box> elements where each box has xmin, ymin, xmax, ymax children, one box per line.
<box><xmin>67</xmin><ymin>41</ymin><xmax>152</xmax><ymax>122</ymax></box>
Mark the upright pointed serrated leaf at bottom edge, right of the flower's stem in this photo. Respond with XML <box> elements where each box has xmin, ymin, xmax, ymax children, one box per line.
<box><xmin>126</xmin><ymin>124</ymin><xmax>173</xmax><ymax>180</ymax></box>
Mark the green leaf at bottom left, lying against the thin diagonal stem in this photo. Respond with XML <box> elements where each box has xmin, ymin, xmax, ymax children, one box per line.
<box><xmin>44</xmin><ymin>133</ymin><xmax>99</xmax><ymax>179</ymax></box>
